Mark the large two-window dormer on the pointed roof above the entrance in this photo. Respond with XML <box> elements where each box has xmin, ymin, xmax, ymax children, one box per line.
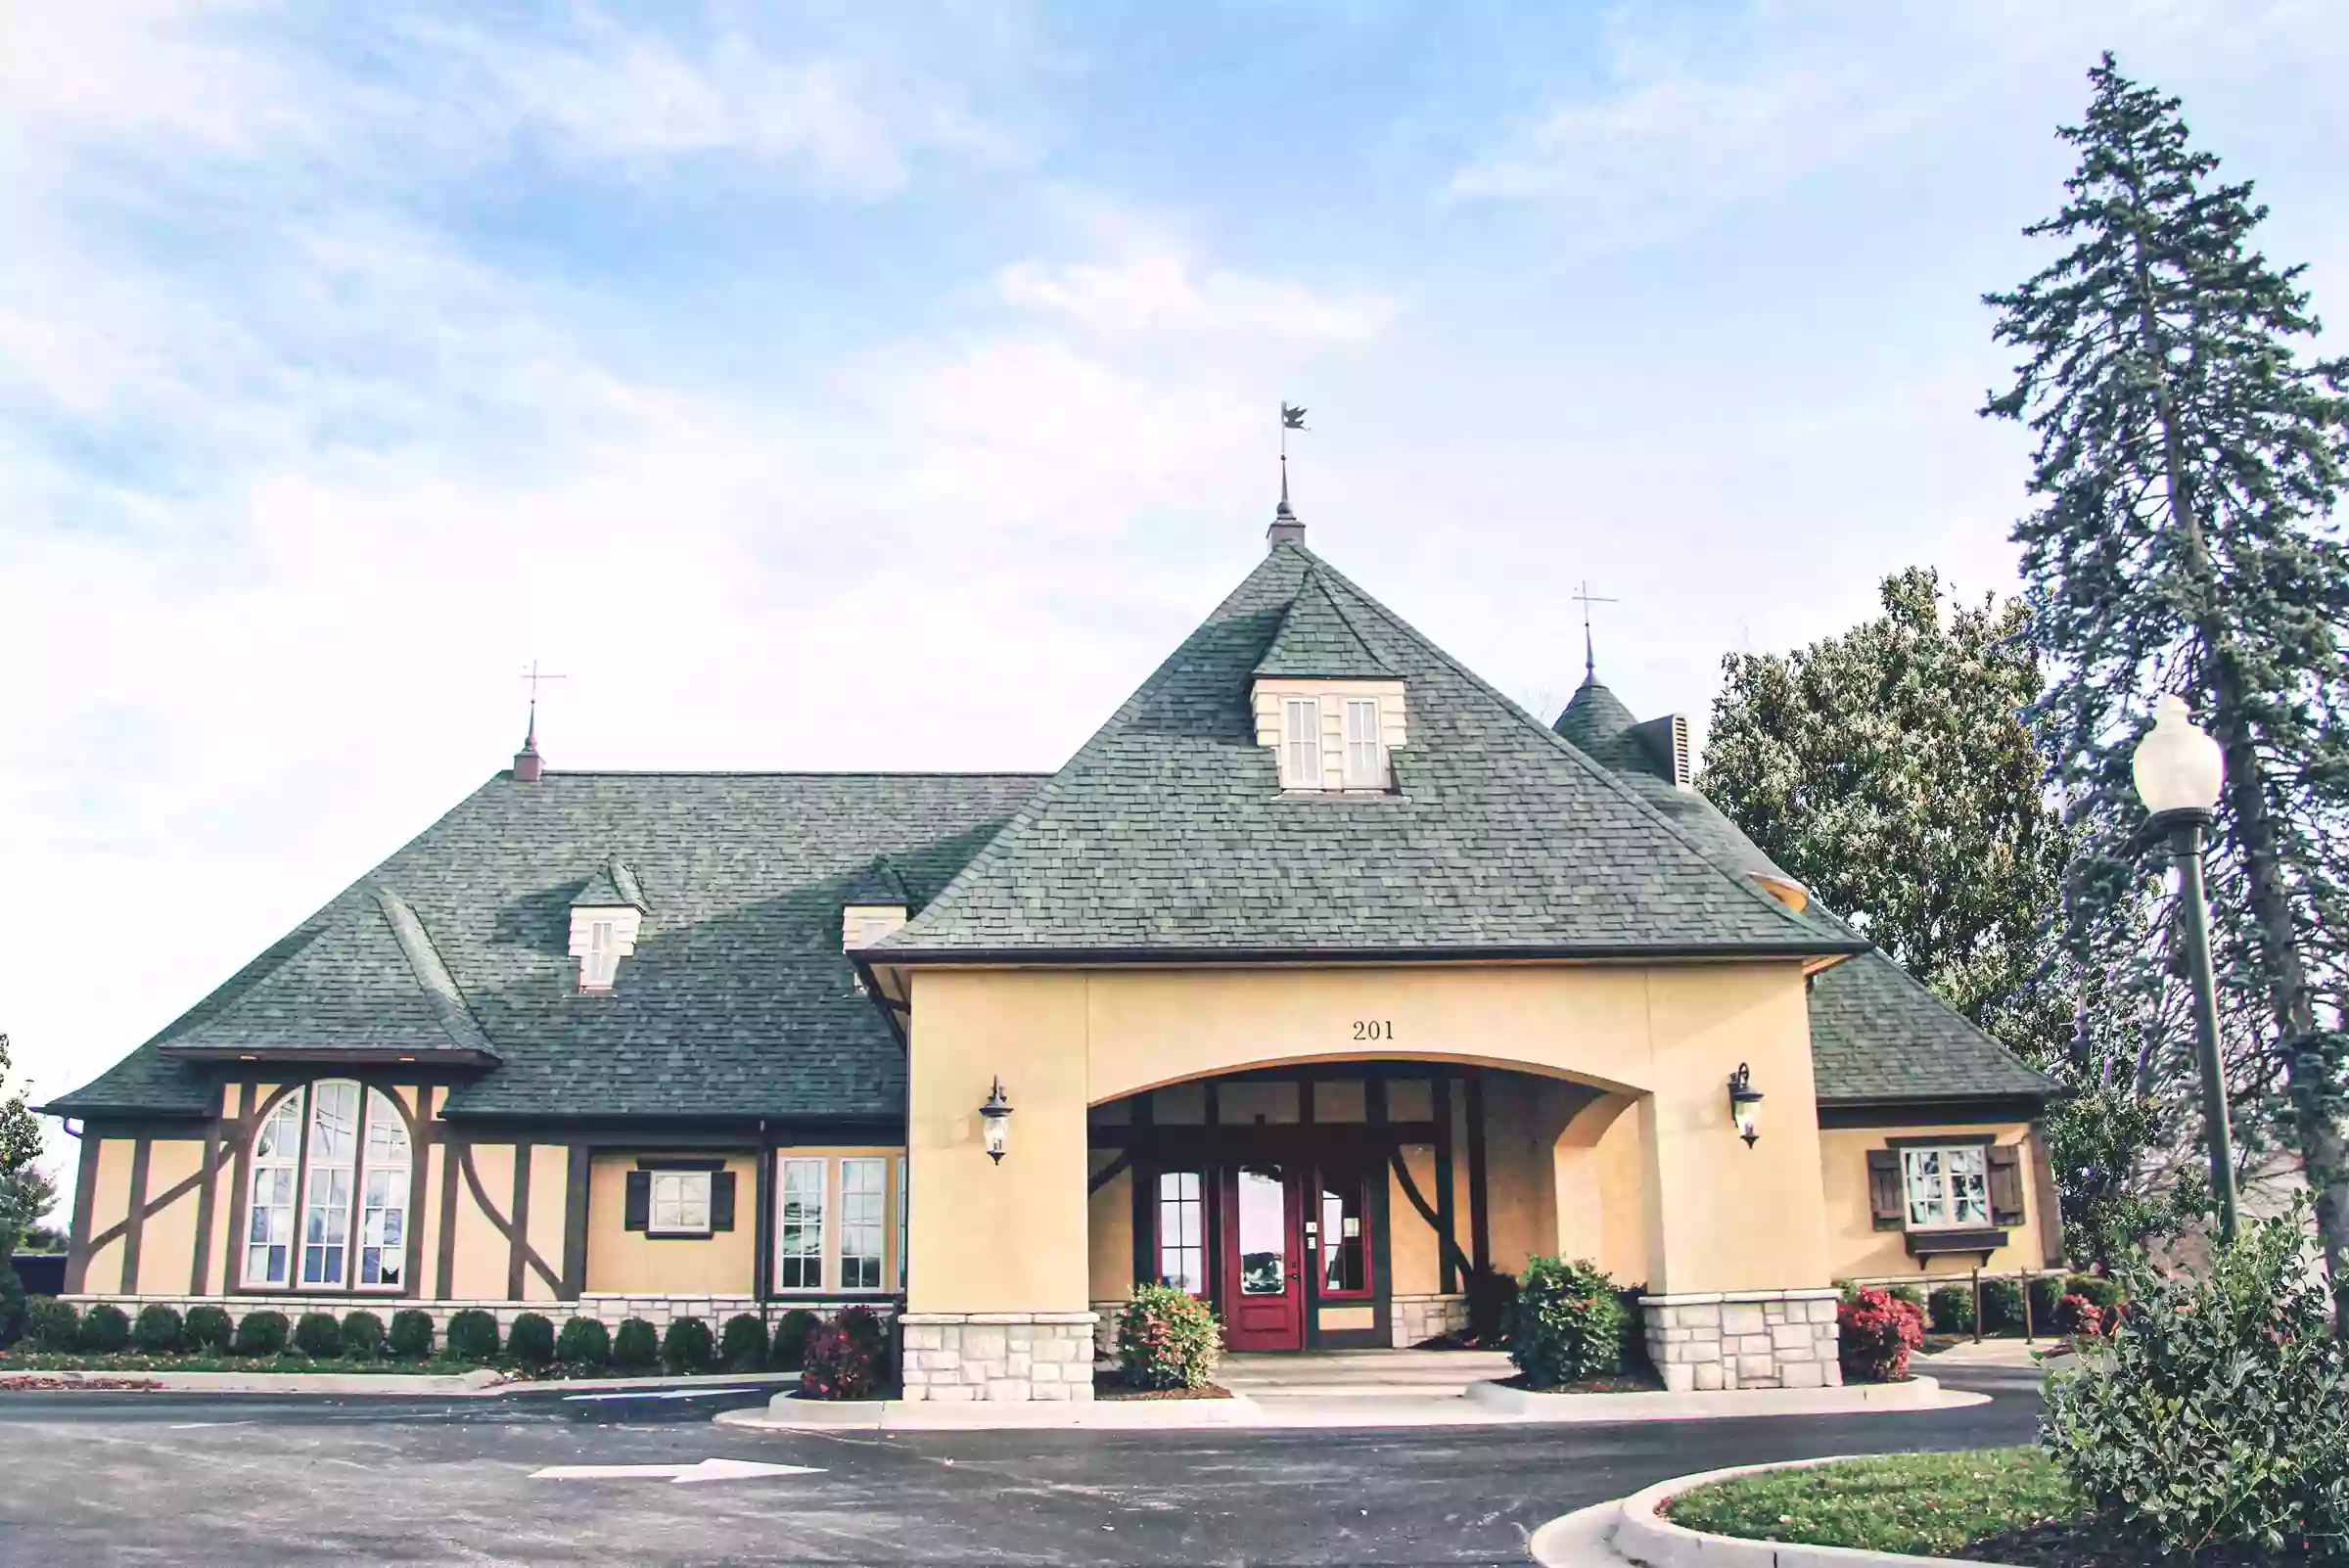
<box><xmin>1250</xmin><ymin>573</ymin><xmax>1409</xmax><ymax>794</ymax></box>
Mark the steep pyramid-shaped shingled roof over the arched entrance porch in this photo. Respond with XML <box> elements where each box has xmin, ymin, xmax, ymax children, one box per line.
<box><xmin>879</xmin><ymin>542</ymin><xmax>1858</xmax><ymax>960</ymax></box>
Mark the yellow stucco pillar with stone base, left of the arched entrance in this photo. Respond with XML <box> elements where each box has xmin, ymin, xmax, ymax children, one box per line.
<box><xmin>899</xmin><ymin>969</ymin><xmax>1094</xmax><ymax>1399</ymax></box>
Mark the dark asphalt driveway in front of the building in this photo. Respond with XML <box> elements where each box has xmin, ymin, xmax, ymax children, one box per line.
<box><xmin>0</xmin><ymin>1368</ymin><xmax>2039</xmax><ymax>1568</ymax></box>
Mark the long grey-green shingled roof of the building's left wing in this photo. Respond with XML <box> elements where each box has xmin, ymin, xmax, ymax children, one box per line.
<box><xmin>47</xmin><ymin>772</ymin><xmax>1038</xmax><ymax>1118</ymax></box>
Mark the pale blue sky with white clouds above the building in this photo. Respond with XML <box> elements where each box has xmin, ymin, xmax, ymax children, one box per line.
<box><xmin>0</xmin><ymin>0</ymin><xmax>2349</xmax><ymax>1201</ymax></box>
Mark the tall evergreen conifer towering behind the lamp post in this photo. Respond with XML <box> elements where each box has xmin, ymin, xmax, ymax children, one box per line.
<box><xmin>1983</xmin><ymin>54</ymin><xmax>2349</xmax><ymax>1286</ymax></box>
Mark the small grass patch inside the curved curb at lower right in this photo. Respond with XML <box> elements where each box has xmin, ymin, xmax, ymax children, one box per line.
<box><xmin>1666</xmin><ymin>1449</ymin><xmax>2093</xmax><ymax>1563</ymax></box>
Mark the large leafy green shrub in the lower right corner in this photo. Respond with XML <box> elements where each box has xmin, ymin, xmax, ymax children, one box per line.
<box><xmin>2039</xmin><ymin>1197</ymin><xmax>2349</xmax><ymax>1561</ymax></box>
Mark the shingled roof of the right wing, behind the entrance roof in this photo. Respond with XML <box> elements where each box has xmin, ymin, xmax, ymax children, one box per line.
<box><xmin>1557</xmin><ymin>676</ymin><xmax>2055</xmax><ymax>1103</ymax></box>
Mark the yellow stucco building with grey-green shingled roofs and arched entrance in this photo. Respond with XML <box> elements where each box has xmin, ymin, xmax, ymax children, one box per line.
<box><xmin>47</xmin><ymin>514</ymin><xmax>2060</xmax><ymax>1399</ymax></box>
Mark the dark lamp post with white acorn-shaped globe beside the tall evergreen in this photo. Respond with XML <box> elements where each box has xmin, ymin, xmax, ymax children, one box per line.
<box><xmin>2128</xmin><ymin>692</ymin><xmax>2234</xmax><ymax>1242</ymax></box>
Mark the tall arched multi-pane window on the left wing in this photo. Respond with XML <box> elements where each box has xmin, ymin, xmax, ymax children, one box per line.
<box><xmin>245</xmin><ymin>1078</ymin><xmax>409</xmax><ymax>1291</ymax></box>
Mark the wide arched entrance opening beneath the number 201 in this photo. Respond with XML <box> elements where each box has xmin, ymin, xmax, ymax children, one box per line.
<box><xmin>1087</xmin><ymin>1056</ymin><xmax>1644</xmax><ymax>1350</ymax></box>
